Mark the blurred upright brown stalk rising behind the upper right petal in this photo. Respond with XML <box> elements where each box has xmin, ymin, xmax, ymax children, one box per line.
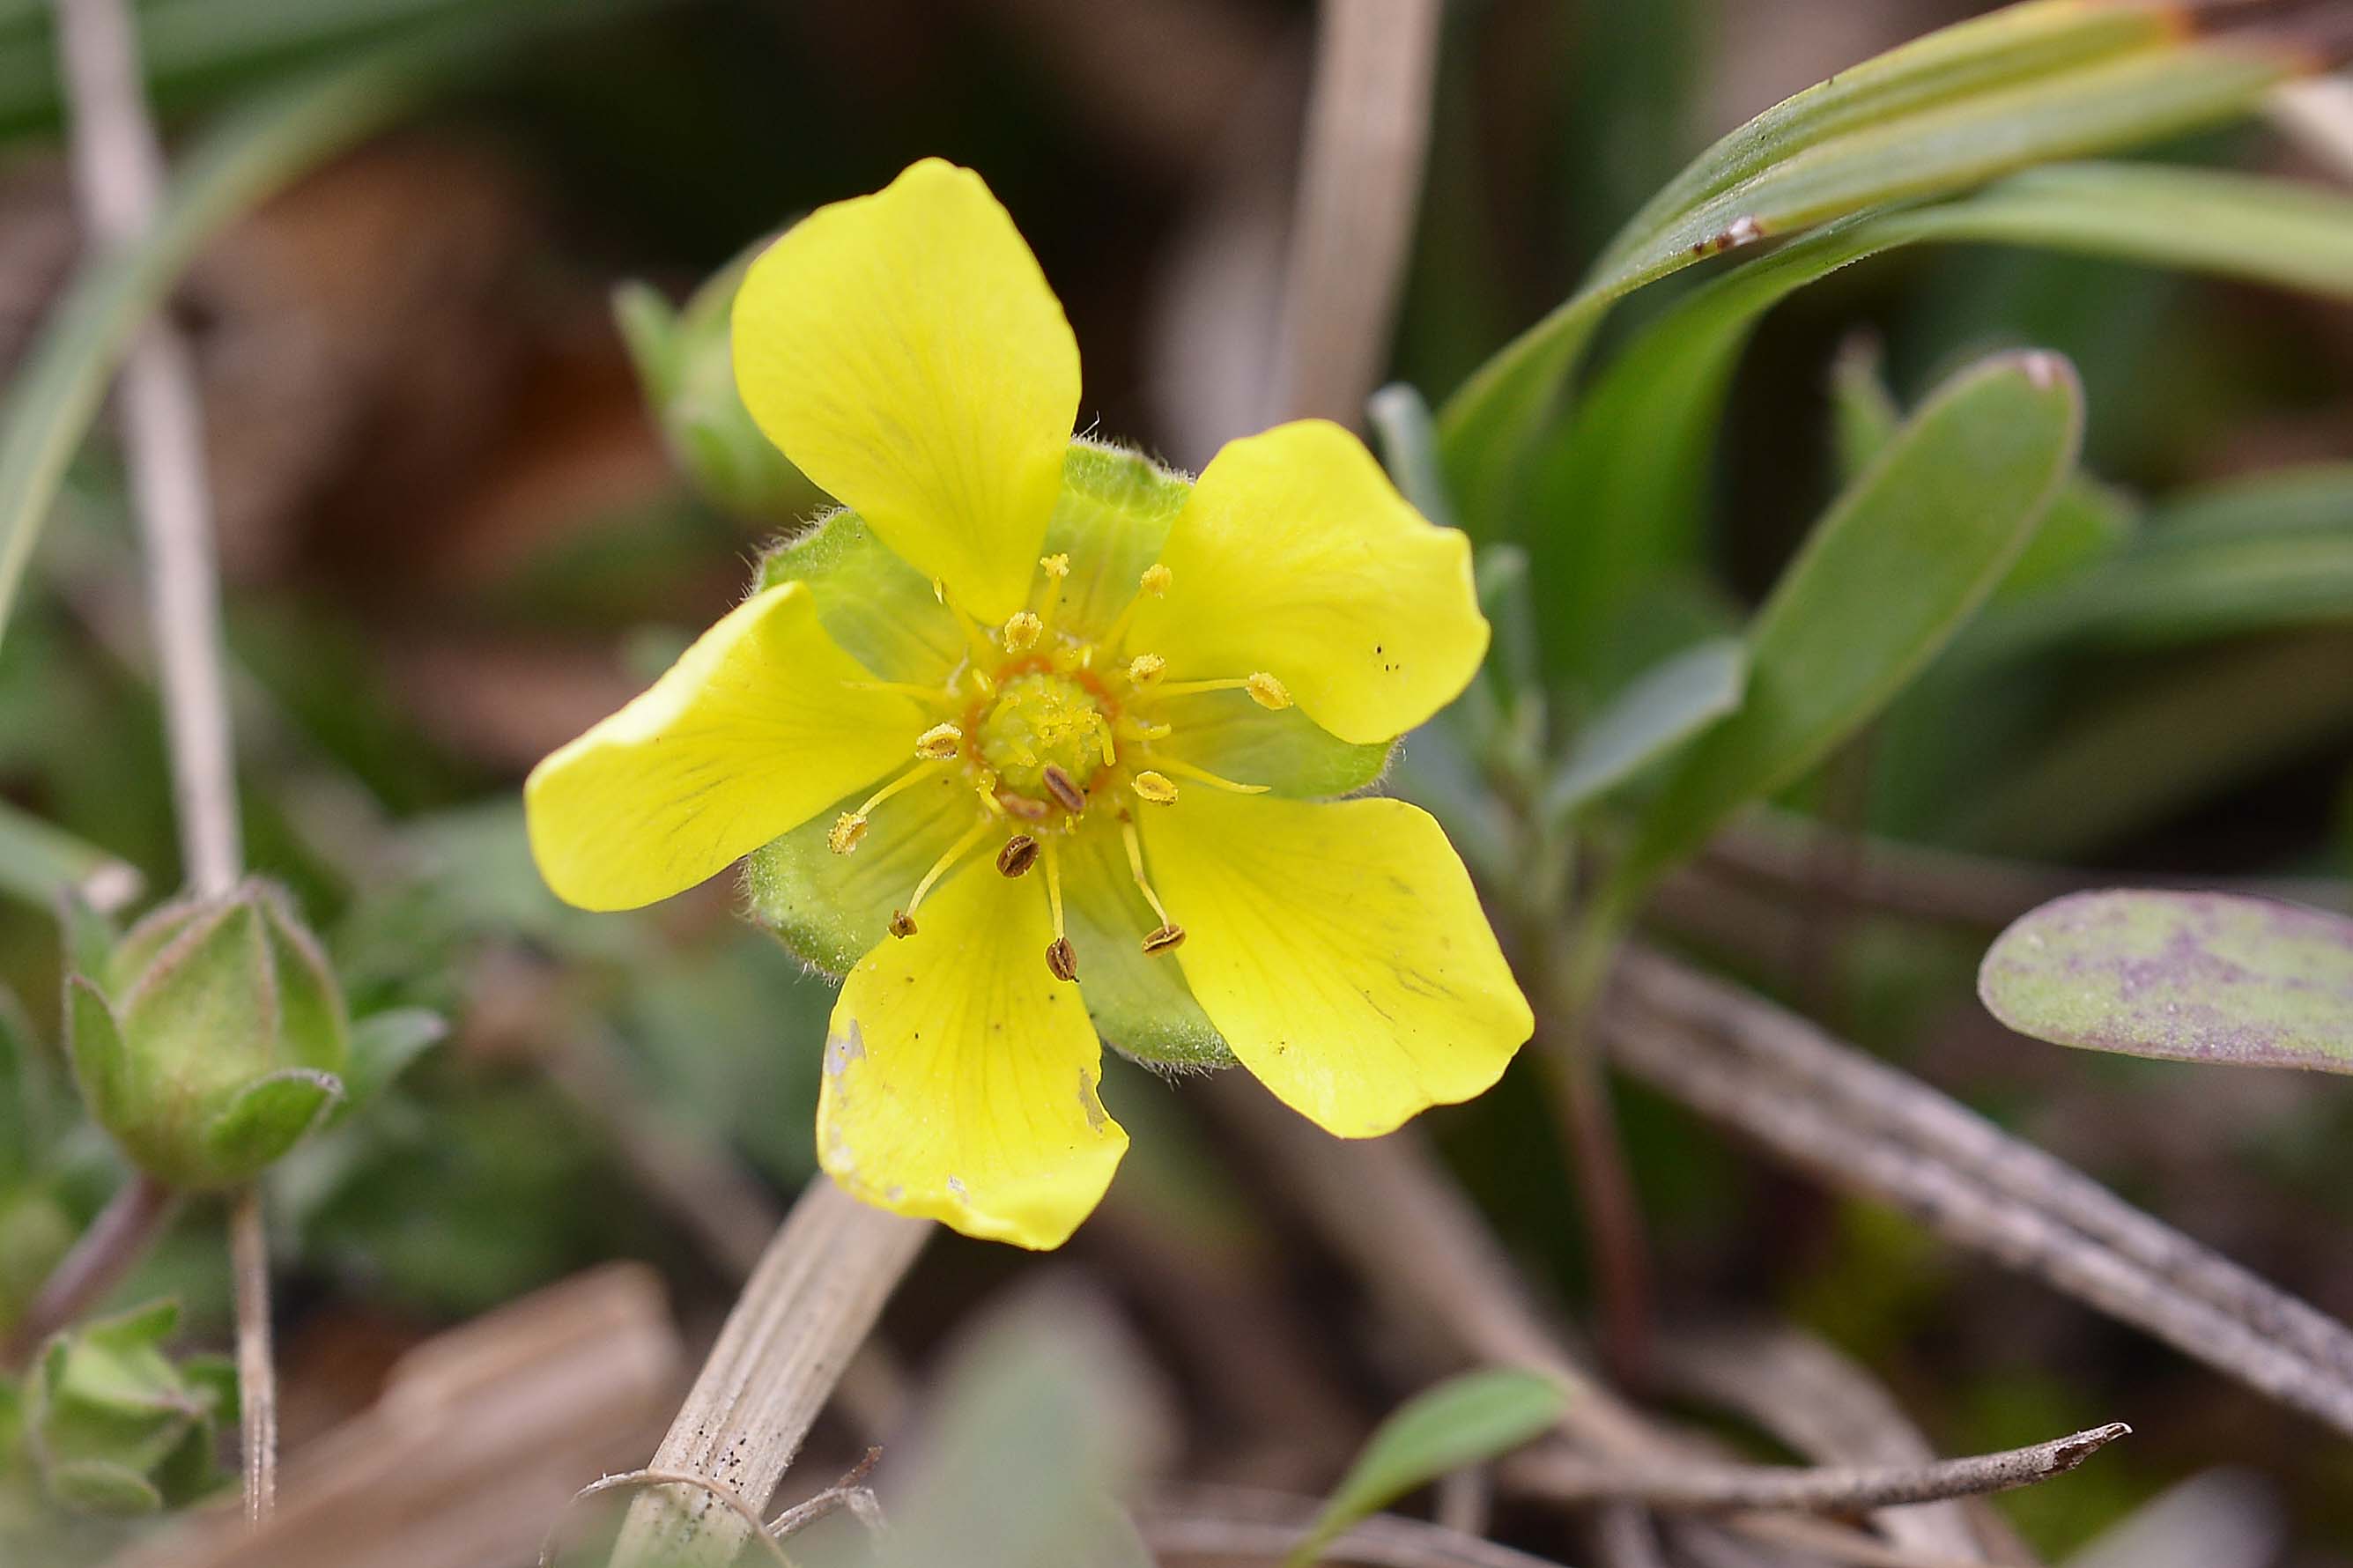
<box><xmin>1273</xmin><ymin>0</ymin><xmax>1442</xmax><ymax>424</ymax></box>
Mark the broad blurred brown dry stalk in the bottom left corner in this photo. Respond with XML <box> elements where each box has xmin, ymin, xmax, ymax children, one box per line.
<box><xmin>108</xmin><ymin>1264</ymin><xmax>680</xmax><ymax>1568</ymax></box>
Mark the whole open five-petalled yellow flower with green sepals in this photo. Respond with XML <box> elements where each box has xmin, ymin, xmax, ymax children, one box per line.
<box><xmin>525</xmin><ymin>160</ymin><xmax>1532</xmax><ymax>1248</ymax></box>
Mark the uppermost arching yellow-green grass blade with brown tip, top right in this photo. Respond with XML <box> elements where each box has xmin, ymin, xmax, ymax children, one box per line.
<box><xmin>1440</xmin><ymin>4</ymin><xmax>2301</xmax><ymax>535</ymax></box>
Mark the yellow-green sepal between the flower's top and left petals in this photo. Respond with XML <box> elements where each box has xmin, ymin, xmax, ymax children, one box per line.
<box><xmin>753</xmin><ymin>511</ymin><xmax>965</xmax><ymax>687</ymax></box>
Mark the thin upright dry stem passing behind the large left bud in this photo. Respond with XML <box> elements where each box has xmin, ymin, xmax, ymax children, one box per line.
<box><xmin>56</xmin><ymin>0</ymin><xmax>277</xmax><ymax>1521</ymax></box>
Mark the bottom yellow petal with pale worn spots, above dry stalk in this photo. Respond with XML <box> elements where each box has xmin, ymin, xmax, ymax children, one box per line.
<box><xmin>817</xmin><ymin>864</ymin><xmax>1127</xmax><ymax>1248</ymax></box>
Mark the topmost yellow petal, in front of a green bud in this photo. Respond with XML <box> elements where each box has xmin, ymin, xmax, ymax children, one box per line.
<box><xmin>734</xmin><ymin>158</ymin><xmax>1077</xmax><ymax>622</ymax></box>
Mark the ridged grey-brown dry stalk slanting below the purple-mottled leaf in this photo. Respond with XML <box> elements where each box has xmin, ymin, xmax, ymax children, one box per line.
<box><xmin>1602</xmin><ymin>951</ymin><xmax>2353</xmax><ymax>1431</ymax></box>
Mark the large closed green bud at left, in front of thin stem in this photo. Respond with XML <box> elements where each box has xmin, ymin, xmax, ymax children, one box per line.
<box><xmin>66</xmin><ymin>881</ymin><xmax>351</xmax><ymax>1191</ymax></box>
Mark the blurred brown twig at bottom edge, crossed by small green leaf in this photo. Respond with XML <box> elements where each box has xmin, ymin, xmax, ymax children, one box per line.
<box><xmin>1134</xmin><ymin>1485</ymin><xmax>1558</xmax><ymax>1568</ymax></box>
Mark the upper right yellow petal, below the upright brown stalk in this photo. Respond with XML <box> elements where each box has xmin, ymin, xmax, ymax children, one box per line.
<box><xmin>1127</xmin><ymin>419</ymin><xmax>1487</xmax><ymax>744</ymax></box>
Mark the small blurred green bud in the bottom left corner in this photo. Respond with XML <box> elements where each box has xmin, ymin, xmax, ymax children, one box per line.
<box><xmin>18</xmin><ymin>1302</ymin><xmax>238</xmax><ymax>1514</ymax></box>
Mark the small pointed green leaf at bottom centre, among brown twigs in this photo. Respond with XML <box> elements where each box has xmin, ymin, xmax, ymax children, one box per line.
<box><xmin>1283</xmin><ymin>1368</ymin><xmax>1570</xmax><ymax>1568</ymax></box>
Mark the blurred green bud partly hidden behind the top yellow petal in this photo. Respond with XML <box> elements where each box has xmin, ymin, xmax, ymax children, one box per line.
<box><xmin>611</xmin><ymin>235</ymin><xmax>824</xmax><ymax>528</ymax></box>
